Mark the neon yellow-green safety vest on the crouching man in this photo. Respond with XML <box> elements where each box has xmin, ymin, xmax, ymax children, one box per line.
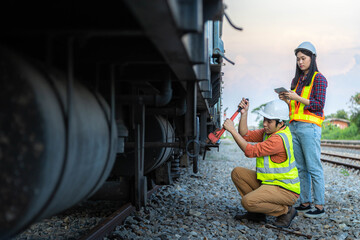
<box><xmin>256</xmin><ymin>127</ymin><xmax>300</xmax><ymax>194</ymax></box>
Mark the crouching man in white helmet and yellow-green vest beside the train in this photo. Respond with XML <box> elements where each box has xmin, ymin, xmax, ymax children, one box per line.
<box><xmin>224</xmin><ymin>98</ymin><xmax>300</xmax><ymax>228</ymax></box>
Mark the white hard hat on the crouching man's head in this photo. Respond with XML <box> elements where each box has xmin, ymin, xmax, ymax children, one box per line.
<box><xmin>259</xmin><ymin>99</ymin><xmax>289</xmax><ymax>120</ymax></box>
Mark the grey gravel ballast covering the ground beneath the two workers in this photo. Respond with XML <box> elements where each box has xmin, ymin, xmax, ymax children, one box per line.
<box><xmin>14</xmin><ymin>139</ymin><xmax>360</xmax><ymax>240</ymax></box>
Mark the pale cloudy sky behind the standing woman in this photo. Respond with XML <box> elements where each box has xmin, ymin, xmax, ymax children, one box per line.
<box><xmin>222</xmin><ymin>0</ymin><xmax>360</xmax><ymax>126</ymax></box>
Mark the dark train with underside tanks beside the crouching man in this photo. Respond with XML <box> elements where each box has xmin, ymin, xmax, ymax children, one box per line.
<box><xmin>0</xmin><ymin>0</ymin><xmax>229</xmax><ymax>239</ymax></box>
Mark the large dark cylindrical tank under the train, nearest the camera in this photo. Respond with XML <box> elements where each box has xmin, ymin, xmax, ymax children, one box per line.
<box><xmin>0</xmin><ymin>48</ymin><xmax>117</xmax><ymax>239</ymax></box>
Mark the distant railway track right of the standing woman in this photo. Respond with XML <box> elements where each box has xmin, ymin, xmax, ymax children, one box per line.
<box><xmin>321</xmin><ymin>140</ymin><xmax>360</xmax><ymax>170</ymax></box>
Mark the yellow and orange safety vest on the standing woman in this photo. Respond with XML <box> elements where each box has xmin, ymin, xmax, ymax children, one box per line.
<box><xmin>290</xmin><ymin>72</ymin><xmax>325</xmax><ymax>127</ymax></box>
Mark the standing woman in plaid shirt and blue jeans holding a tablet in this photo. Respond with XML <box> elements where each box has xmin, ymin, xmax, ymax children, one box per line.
<box><xmin>279</xmin><ymin>42</ymin><xmax>327</xmax><ymax>218</ymax></box>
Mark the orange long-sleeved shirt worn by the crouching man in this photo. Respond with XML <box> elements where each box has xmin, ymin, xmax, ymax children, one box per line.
<box><xmin>243</xmin><ymin>127</ymin><xmax>287</xmax><ymax>163</ymax></box>
